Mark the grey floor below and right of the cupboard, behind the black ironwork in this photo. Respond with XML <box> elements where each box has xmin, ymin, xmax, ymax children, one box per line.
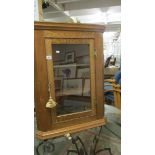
<box><xmin>34</xmin><ymin>105</ymin><xmax>121</xmax><ymax>155</ymax></box>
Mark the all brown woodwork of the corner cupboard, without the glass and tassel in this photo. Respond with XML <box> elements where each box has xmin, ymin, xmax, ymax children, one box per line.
<box><xmin>34</xmin><ymin>22</ymin><xmax>105</xmax><ymax>136</ymax></box>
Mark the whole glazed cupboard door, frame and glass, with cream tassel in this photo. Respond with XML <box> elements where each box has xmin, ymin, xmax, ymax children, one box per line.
<box><xmin>45</xmin><ymin>39</ymin><xmax>96</xmax><ymax>123</ymax></box>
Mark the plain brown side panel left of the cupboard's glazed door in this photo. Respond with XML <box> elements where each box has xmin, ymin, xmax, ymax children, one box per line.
<box><xmin>34</xmin><ymin>30</ymin><xmax>52</xmax><ymax>131</ymax></box>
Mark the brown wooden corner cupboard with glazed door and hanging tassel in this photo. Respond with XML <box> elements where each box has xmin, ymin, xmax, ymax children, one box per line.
<box><xmin>34</xmin><ymin>22</ymin><xmax>105</xmax><ymax>139</ymax></box>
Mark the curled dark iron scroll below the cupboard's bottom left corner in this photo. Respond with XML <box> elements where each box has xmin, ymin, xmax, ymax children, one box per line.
<box><xmin>36</xmin><ymin>140</ymin><xmax>55</xmax><ymax>155</ymax></box>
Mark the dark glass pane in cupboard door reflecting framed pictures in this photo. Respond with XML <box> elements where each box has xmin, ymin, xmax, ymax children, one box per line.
<box><xmin>52</xmin><ymin>44</ymin><xmax>91</xmax><ymax>115</ymax></box>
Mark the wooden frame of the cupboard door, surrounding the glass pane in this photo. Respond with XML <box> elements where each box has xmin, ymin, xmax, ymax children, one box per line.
<box><xmin>45</xmin><ymin>38</ymin><xmax>96</xmax><ymax>124</ymax></box>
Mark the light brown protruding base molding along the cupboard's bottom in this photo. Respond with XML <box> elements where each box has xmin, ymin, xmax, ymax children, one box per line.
<box><xmin>36</xmin><ymin>118</ymin><xmax>106</xmax><ymax>140</ymax></box>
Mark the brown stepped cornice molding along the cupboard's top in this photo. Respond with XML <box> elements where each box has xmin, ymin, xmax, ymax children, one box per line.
<box><xmin>34</xmin><ymin>22</ymin><xmax>105</xmax><ymax>32</ymax></box>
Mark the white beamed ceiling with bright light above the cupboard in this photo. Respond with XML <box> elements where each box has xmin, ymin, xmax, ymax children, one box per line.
<box><xmin>43</xmin><ymin>0</ymin><xmax>121</xmax><ymax>32</ymax></box>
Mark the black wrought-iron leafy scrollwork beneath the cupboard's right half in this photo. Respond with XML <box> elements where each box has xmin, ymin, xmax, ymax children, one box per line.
<box><xmin>67</xmin><ymin>126</ymin><xmax>112</xmax><ymax>155</ymax></box>
